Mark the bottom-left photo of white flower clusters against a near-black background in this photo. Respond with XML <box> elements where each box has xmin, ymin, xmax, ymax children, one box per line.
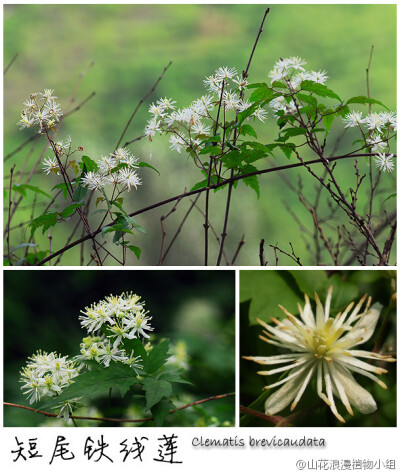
<box><xmin>4</xmin><ymin>270</ymin><xmax>235</xmax><ymax>427</ymax></box>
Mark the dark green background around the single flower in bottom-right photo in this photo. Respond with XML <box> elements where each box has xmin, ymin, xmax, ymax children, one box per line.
<box><xmin>240</xmin><ymin>270</ymin><xmax>397</xmax><ymax>427</ymax></box>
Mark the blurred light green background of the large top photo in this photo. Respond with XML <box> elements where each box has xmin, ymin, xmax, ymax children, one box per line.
<box><xmin>4</xmin><ymin>5</ymin><xmax>396</xmax><ymax>265</ymax></box>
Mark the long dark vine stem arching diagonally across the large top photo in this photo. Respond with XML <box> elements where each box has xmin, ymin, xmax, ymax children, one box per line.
<box><xmin>36</xmin><ymin>153</ymin><xmax>395</xmax><ymax>266</ymax></box>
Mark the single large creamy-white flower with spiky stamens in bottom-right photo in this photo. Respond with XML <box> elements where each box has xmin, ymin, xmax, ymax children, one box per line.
<box><xmin>244</xmin><ymin>286</ymin><xmax>395</xmax><ymax>422</ymax></box>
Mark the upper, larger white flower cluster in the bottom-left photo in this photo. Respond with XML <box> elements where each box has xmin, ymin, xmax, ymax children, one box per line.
<box><xmin>79</xmin><ymin>292</ymin><xmax>153</xmax><ymax>370</ymax></box>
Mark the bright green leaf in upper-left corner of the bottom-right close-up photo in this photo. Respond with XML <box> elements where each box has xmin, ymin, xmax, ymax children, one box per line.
<box><xmin>240</xmin><ymin>270</ymin><xmax>302</xmax><ymax>325</ymax></box>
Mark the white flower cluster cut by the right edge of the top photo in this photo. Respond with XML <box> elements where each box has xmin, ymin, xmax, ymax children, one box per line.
<box><xmin>343</xmin><ymin>111</ymin><xmax>397</xmax><ymax>172</ymax></box>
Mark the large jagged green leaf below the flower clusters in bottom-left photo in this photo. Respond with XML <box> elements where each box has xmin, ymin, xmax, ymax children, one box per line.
<box><xmin>39</xmin><ymin>361</ymin><xmax>140</xmax><ymax>409</ymax></box>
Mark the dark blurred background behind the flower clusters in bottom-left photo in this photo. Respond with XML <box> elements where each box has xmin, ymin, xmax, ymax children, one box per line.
<box><xmin>4</xmin><ymin>270</ymin><xmax>235</xmax><ymax>426</ymax></box>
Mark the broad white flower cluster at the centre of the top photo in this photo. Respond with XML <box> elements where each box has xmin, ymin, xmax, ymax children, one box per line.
<box><xmin>144</xmin><ymin>67</ymin><xmax>267</xmax><ymax>153</ymax></box>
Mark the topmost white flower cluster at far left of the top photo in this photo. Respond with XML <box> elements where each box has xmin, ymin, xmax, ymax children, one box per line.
<box><xmin>17</xmin><ymin>89</ymin><xmax>62</xmax><ymax>133</ymax></box>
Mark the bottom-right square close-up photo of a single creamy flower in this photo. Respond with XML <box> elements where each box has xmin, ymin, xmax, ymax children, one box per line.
<box><xmin>240</xmin><ymin>270</ymin><xmax>397</xmax><ymax>427</ymax></box>
